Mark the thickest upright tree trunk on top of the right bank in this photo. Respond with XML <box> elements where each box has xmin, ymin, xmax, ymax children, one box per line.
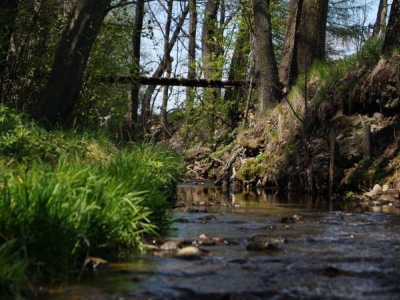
<box><xmin>297</xmin><ymin>0</ymin><xmax>329</xmax><ymax>73</ymax></box>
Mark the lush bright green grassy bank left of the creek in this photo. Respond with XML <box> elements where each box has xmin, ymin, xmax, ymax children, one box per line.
<box><xmin>0</xmin><ymin>106</ymin><xmax>182</xmax><ymax>295</ymax></box>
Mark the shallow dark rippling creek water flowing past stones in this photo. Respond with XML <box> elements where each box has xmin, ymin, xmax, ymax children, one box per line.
<box><xmin>40</xmin><ymin>184</ymin><xmax>400</xmax><ymax>300</ymax></box>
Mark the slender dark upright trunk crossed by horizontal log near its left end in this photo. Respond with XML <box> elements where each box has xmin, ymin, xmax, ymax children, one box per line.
<box><xmin>131</xmin><ymin>0</ymin><xmax>144</xmax><ymax>127</ymax></box>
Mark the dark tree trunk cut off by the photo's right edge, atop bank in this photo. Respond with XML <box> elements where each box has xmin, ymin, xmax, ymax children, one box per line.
<box><xmin>382</xmin><ymin>0</ymin><xmax>400</xmax><ymax>56</ymax></box>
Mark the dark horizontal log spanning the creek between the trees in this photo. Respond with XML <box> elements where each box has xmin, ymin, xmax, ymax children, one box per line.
<box><xmin>102</xmin><ymin>76</ymin><xmax>250</xmax><ymax>89</ymax></box>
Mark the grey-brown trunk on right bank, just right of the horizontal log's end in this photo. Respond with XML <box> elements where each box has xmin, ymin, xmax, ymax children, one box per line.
<box><xmin>253</xmin><ymin>0</ymin><xmax>281</xmax><ymax>117</ymax></box>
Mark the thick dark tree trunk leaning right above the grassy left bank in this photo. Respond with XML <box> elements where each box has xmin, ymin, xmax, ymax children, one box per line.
<box><xmin>34</xmin><ymin>0</ymin><xmax>111</xmax><ymax>127</ymax></box>
